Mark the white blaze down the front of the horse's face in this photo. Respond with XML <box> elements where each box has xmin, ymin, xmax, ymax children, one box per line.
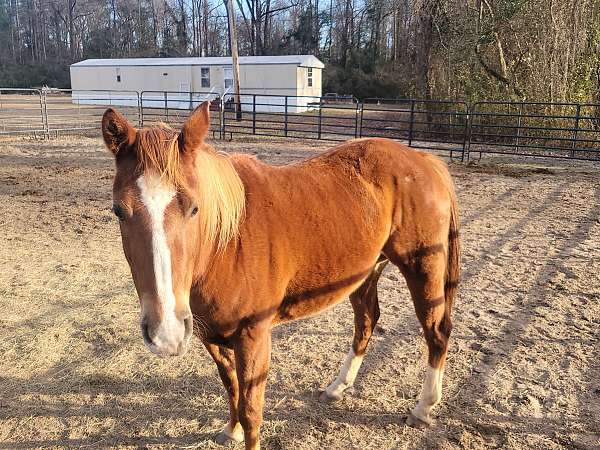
<box><xmin>137</xmin><ymin>174</ymin><xmax>184</xmax><ymax>348</ymax></box>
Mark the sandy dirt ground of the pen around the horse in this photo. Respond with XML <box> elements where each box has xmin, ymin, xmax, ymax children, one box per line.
<box><xmin>0</xmin><ymin>134</ymin><xmax>600</xmax><ymax>450</ymax></box>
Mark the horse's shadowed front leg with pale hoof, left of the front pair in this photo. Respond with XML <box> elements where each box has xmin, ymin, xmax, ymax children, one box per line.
<box><xmin>204</xmin><ymin>342</ymin><xmax>244</xmax><ymax>445</ymax></box>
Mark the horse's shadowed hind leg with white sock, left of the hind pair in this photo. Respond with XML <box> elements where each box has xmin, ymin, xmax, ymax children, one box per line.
<box><xmin>321</xmin><ymin>258</ymin><xmax>389</xmax><ymax>401</ymax></box>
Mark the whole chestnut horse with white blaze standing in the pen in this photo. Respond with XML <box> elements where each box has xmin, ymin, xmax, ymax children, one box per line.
<box><xmin>102</xmin><ymin>103</ymin><xmax>460</xmax><ymax>449</ymax></box>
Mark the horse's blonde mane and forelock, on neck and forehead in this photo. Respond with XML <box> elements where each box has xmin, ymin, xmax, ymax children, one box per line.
<box><xmin>137</xmin><ymin>124</ymin><xmax>246</xmax><ymax>250</ymax></box>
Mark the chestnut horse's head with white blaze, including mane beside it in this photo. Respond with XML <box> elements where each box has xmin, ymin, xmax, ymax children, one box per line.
<box><xmin>102</xmin><ymin>102</ymin><xmax>243</xmax><ymax>356</ymax></box>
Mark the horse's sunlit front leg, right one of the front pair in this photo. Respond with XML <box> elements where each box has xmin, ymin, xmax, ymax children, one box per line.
<box><xmin>234</xmin><ymin>323</ymin><xmax>271</xmax><ymax>450</ymax></box>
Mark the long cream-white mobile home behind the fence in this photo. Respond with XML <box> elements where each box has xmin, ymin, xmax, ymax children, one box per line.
<box><xmin>71</xmin><ymin>55</ymin><xmax>324</xmax><ymax>112</ymax></box>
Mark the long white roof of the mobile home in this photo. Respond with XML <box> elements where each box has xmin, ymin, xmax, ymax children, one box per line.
<box><xmin>71</xmin><ymin>55</ymin><xmax>325</xmax><ymax>69</ymax></box>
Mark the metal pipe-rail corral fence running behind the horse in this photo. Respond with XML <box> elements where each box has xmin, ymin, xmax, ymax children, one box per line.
<box><xmin>0</xmin><ymin>88</ymin><xmax>600</xmax><ymax>161</ymax></box>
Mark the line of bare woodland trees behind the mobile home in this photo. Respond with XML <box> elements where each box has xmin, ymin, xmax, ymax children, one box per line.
<box><xmin>0</xmin><ymin>0</ymin><xmax>600</xmax><ymax>102</ymax></box>
